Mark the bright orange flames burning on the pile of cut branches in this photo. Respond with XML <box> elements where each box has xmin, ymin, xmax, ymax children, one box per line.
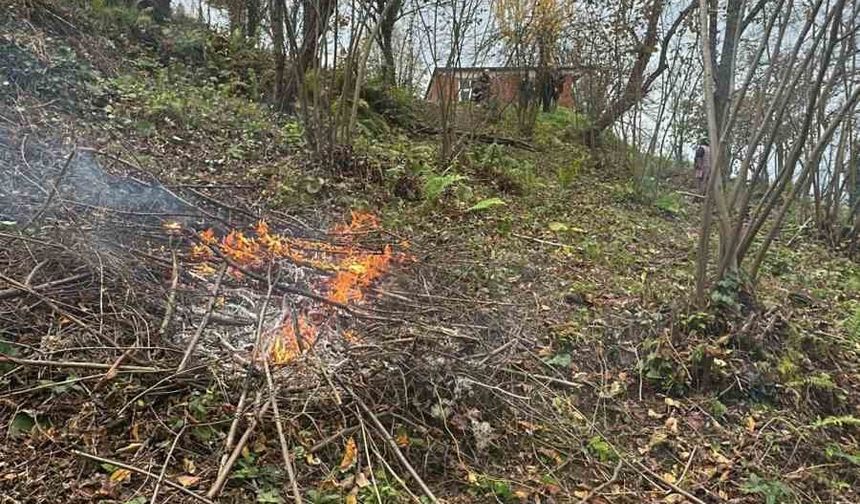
<box><xmin>186</xmin><ymin>212</ymin><xmax>399</xmax><ymax>364</ymax></box>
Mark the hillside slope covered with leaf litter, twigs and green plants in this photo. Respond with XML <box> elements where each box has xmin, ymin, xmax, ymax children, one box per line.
<box><xmin>0</xmin><ymin>1</ymin><xmax>860</xmax><ymax>503</ymax></box>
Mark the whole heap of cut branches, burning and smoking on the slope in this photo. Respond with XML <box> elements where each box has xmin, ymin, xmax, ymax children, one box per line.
<box><xmin>0</xmin><ymin>132</ymin><xmax>552</xmax><ymax>502</ymax></box>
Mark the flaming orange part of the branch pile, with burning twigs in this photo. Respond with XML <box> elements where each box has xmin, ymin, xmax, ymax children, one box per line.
<box><xmin>191</xmin><ymin>212</ymin><xmax>406</xmax><ymax>364</ymax></box>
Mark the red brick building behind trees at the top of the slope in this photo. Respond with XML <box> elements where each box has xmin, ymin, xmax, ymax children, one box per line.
<box><xmin>424</xmin><ymin>67</ymin><xmax>579</xmax><ymax>108</ymax></box>
